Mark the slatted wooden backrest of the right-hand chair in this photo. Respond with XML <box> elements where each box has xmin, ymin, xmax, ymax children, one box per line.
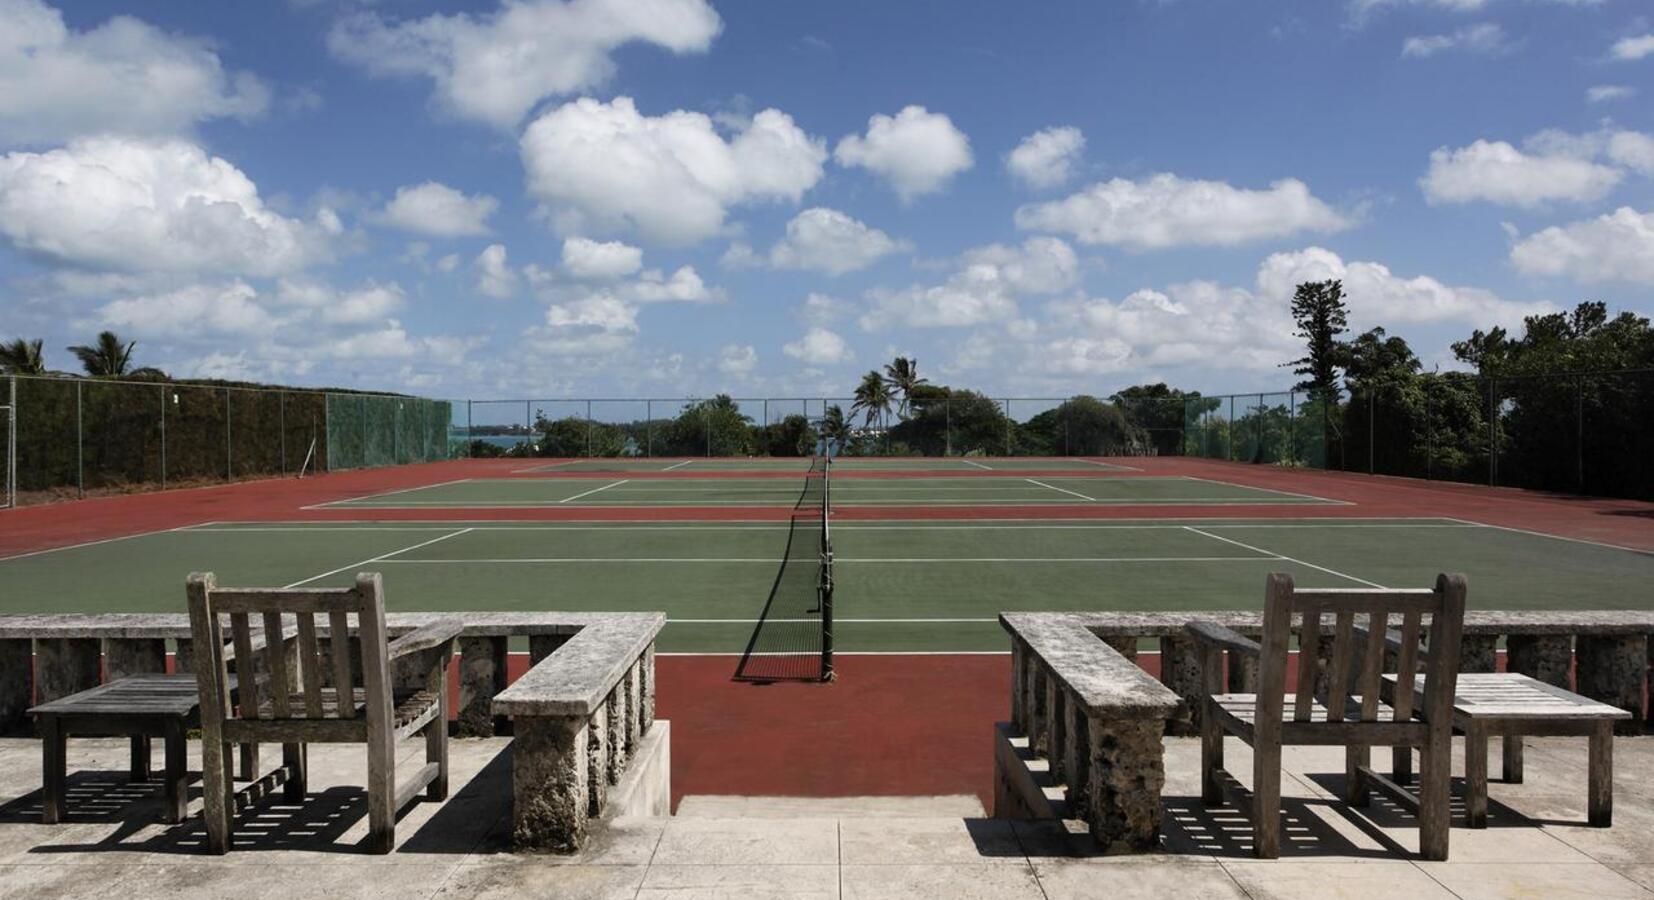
<box><xmin>1255</xmin><ymin>572</ymin><xmax>1465</xmax><ymax>726</ymax></box>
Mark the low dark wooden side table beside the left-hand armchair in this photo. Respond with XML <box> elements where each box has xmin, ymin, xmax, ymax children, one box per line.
<box><xmin>30</xmin><ymin>675</ymin><xmax>200</xmax><ymax>826</ymax></box>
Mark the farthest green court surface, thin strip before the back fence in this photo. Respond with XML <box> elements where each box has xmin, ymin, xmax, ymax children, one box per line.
<box><xmin>514</xmin><ymin>457</ymin><xmax>1138</xmax><ymax>473</ymax></box>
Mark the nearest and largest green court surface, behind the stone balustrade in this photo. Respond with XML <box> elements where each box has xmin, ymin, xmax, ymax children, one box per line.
<box><xmin>0</xmin><ymin>518</ymin><xmax>1654</xmax><ymax>652</ymax></box>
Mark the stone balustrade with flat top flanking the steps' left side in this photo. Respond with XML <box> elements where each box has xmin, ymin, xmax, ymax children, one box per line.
<box><xmin>491</xmin><ymin>612</ymin><xmax>670</xmax><ymax>852</ymax></box>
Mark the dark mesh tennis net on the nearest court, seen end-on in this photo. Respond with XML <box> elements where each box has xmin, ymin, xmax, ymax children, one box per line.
<box><xmin>734</xmin><ymin>457</ymin><xmax>834</xmax><ymax>682</ymax></box>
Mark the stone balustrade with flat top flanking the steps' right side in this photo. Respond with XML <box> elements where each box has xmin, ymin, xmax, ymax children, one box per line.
<box><xmin>994</xmin><ymin>612</ymin><xmax>1183</xmax><ymax>852</ymax></box>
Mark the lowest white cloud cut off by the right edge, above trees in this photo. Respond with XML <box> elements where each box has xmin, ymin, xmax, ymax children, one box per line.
<box><xmin>1510</xmin><ymin>207</ymin><xmax>1654</xmax><ymax>285</ymax></box>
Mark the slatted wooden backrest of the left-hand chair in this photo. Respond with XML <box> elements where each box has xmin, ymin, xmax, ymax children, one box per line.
<box><xmin>189</xmin><ymin>572</ymin><xmax>390</xmax><ymax>723</ymax></box>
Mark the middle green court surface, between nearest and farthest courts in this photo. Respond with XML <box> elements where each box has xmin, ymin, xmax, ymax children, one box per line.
<box><xmin>318</xmin><ymin>476</ymin><xmax>1336</xmax><ymax>510</ymax></box>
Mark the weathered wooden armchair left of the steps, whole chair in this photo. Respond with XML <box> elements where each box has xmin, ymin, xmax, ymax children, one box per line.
<box><xmin>189</xmin><ymin>572</ymin><xmax>460</xmax><ymax>854</ymax></box>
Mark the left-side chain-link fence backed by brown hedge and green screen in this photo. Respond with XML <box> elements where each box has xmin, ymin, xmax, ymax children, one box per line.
<box><xmin>0</xmin><ymin>376</ymin><xmax>452</xmax><ymax>503</ymax></box>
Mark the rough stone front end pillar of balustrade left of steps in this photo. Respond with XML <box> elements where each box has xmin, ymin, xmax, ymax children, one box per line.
<box><xmin>511</xmin><ymin>716</ymin><xmax>592</xmax><ymax>854</ymax></box>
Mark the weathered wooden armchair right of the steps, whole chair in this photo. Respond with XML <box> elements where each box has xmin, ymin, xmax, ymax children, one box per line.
<box><xmin>1186</xmin><ymin>574</ymin><xmax>1465</xmax><ymax>860</ymax></box>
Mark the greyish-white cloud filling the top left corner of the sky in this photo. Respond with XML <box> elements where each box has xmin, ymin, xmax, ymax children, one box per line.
<box><xmin>0</xmin><ymin>0</ymin><xmax>270</xmax><ymax>146</ymax></box>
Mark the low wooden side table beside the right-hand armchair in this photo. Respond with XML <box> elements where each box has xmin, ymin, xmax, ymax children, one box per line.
<box><xmin>1384</xmin><ymin>672</ymin><xmax>1631</xmax><ymax>829</ymax></box>
